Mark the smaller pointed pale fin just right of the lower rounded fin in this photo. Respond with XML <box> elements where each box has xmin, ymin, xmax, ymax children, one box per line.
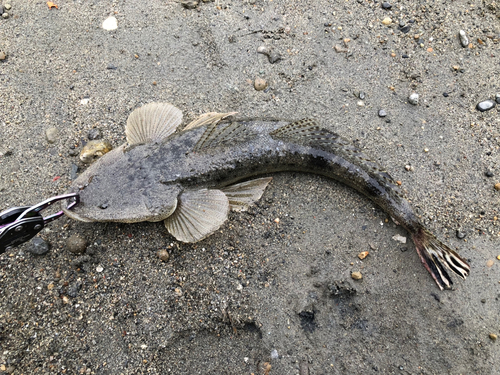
<box><xmin>221</xmin><ymin>177</ymin><xmax>273</xmax><ymax>211</ymax></box>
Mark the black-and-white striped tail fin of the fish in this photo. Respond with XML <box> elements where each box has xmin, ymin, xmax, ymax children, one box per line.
<box><xmin>412</xmin><ymin>225</ymin><xmax>470</xmax><ymax>290</ymax></box>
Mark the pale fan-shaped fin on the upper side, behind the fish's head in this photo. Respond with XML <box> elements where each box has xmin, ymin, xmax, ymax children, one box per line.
<box><xmin>125</xmin><ymin>103</ymin><xmax>182</xmax><ymax>145</ymax></box>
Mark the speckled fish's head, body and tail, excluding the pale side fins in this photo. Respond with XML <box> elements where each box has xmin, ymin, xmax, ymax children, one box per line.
<box><xmin>66</xmin><ymin>106</ymin><xmax>469</xmax><ymax>289</ymax></box>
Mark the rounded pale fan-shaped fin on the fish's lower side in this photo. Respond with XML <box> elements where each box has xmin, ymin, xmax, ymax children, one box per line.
<box><xmin>164</xmin><ymin>189</ymin><xmax>229</xmax><ymax>242</ymax></box>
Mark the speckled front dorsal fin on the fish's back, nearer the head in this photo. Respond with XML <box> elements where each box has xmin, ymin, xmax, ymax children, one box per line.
<box><xmin>193</xmin><ymin>122</ymin><xmax>254</xmax><ymax>151</ymax></box>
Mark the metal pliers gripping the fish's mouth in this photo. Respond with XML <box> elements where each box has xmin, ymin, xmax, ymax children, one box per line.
<box><xmin>0</xmin><ymin>193</ymin><xmax>80</xmax><ymax>254</ymax></box>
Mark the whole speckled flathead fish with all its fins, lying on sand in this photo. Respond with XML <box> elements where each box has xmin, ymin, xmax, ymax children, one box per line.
<box><xmin>65</xmin><ymin>103</ymin><xmax>469</xmax><ymax>289</ymax></box>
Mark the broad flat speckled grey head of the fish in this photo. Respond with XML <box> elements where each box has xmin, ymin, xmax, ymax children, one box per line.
<box><xmin>63</xmin><ymin>145</ymin><xmax>182</xmax><ymax>223</ymax></box>
